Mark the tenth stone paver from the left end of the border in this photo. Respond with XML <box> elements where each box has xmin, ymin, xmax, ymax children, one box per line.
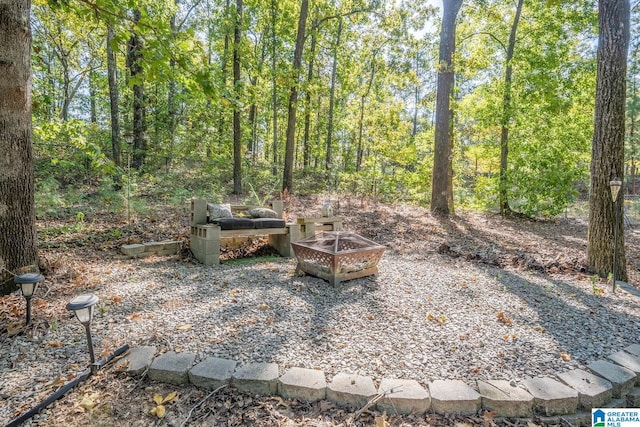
<box><xmin>523</xmin><ymin>378</ymin><xmax>578</xmax><ymax>416</ymax></box>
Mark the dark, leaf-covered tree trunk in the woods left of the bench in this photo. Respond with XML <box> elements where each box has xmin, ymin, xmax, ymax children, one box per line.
<box><xmin>127</xmin><ymin>9</ymin><xmax>147</xmax><ymax>169</ymax></box>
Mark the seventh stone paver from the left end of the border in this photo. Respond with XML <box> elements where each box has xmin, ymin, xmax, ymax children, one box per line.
<box><xmin>377</xmin><ymin>378</ymin><xmax>431</xmax><ymax>414</ymax></box>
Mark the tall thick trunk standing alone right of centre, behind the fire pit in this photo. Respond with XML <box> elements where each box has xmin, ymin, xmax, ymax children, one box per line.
<box><xmin>431</xmin><ymin>0</ymin><xmax>462</xmax><ymax>215</ymax></box>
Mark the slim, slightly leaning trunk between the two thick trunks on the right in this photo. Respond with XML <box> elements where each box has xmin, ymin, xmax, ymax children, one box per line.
<box><xmin>498</xmin><ymin>0</ymin><xmax>524</xmax><ymax>215</ymax></box>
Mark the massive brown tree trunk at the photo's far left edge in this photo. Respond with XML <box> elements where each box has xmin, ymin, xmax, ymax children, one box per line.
<box><xmin>0</xmin><ymin>0</ymin><xmax>38</xmax><ymax>295</ymax></box>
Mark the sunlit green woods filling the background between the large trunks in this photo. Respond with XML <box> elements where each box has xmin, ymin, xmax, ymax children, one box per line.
<box><xmin>32</xmin><ymin>0</ymin><xmax>640</xmax><ymax>216</ymax></box>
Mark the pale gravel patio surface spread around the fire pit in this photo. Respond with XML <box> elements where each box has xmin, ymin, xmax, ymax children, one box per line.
<box><xmin>0</xmin><ymin>252</ymin><xmax>640</xmax><ymax>422</ymax></box>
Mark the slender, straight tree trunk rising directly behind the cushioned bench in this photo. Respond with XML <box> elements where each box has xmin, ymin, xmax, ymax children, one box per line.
<box><xmin>233</xmin><ymin>0</ymin><xmax>242</xmax><ymax>194</ymax></box>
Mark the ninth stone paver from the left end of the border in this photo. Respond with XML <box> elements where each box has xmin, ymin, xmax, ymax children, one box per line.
<box><xmin>478</xmin><ymin>380</ymin><xmax>533</xmax><ymax>418</ymax></box>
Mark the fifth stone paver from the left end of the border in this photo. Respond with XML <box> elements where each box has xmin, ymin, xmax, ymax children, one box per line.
<box><xmin>278</xmin><ymin>368</ymin><xmax>327</xmax><ymax>402</ymax></box>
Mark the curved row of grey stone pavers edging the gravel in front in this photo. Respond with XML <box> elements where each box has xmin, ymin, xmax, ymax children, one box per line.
<box><xmin>118</xmin><ymin>344</ymin><xmax>640</xmax><ymax>424</ymax></box>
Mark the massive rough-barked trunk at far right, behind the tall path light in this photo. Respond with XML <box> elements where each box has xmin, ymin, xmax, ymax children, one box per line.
<box><xmin>587</xmin><ymin>0</ymin><xmax>629</xmax><ymax>280</ymax></box>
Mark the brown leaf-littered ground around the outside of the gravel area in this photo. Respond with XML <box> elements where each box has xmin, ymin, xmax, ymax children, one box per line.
<box><xmin>0</xmin><ymin>198</ymin><xmax>640</xmax><ymax>426</ymax></box>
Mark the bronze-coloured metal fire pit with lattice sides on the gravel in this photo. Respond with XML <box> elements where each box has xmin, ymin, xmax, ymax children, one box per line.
<box><xmin>291</xmin><ymin>231</ymin><xmax>384</xmax><ymax>286</ymax></box>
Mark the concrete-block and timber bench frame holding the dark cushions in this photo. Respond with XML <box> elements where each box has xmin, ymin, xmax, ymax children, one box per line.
<box><xmin>189</xmin><ymin>199</ymin><xmax>300</xmax><ymax>265</ymax></box>
